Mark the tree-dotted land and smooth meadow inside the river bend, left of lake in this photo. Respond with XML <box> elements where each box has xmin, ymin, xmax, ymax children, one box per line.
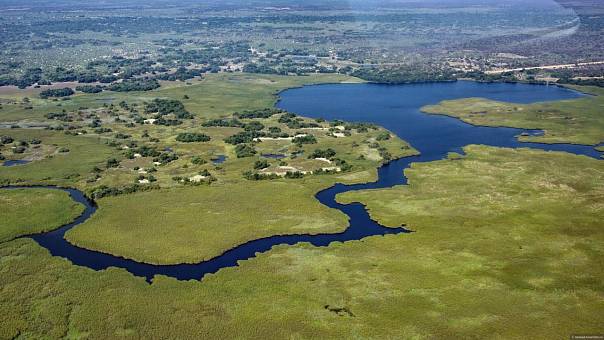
<box><xmin>7</xmin><ymin>71</ymin><xmax>416</xmax><ymax>263</ymax></box>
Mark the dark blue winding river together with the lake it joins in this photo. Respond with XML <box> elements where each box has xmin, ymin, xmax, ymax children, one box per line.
<box><xmin>3</xmin><ymin>82</ymin><xmax>600</xmax><ymax>281</ymax></box>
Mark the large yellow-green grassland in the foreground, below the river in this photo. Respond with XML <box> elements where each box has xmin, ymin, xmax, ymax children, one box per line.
<box><xmin>0</xmin><ymin>146</ymin><xmax>604</xmax><ymax>339</ymax></box>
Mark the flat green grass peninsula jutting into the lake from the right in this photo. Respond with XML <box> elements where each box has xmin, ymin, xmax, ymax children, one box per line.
<box><xmin>422</xmin><ymin>86</ymin><xmax>604</xmax><ymax>145</ymax></box>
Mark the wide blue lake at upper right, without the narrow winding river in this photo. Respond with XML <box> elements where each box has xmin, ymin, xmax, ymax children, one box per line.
<box><xmin>277</xmin><ymin>81</ymin><xmax>596</xmax><ymax>157</ymax></box>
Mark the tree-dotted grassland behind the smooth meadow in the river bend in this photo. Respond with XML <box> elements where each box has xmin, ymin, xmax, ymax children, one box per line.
<box><xmin>0</xmin><ymin>74</ymin><xmax>402</xmax><ymax>215</ymax></box>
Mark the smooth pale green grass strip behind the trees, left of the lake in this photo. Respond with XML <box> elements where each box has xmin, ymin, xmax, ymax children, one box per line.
<box><xmin>0</xmin><ymin>73</ymin><xmax>361</xmax><ymax>122</ymax></box>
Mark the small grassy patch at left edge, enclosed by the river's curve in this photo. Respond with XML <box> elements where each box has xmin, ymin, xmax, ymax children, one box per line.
<box><xmin>0</xmin><ymin>188</ymin><xmax>84</xmax><ymax>242</ymax></box>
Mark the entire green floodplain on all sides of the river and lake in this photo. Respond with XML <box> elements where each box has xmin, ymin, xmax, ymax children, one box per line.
<box><xmin>0</xmin><ymin>74</ymin><xmax>604</xmax><ymax>339</ymax></box>
